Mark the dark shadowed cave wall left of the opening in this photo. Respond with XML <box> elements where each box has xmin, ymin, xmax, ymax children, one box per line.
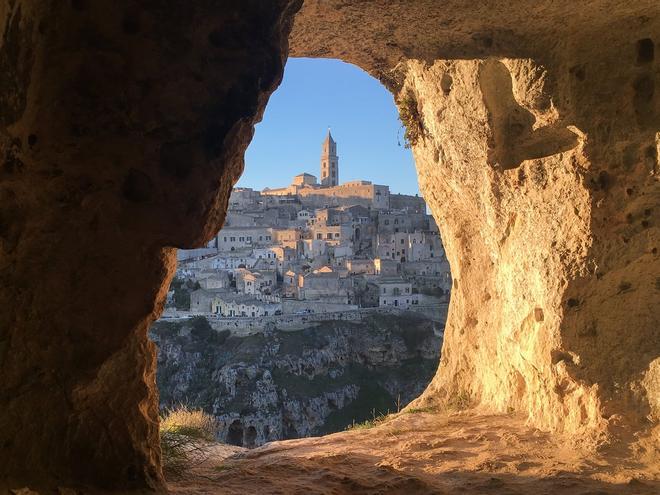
<box><xmin>0</xmin><ymin>0</ymin><xmax>299</xmax><ymax>491</ymax></box>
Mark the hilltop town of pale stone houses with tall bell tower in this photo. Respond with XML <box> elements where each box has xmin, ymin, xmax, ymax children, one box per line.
<box><xmin>169</xmin><ymin>131</ymin><xmax>451</xmax><ymax>319</ymax></box>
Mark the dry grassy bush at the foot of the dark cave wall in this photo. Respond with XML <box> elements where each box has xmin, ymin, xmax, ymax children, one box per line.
<box><xmin>160</xmin><ymin>405</ymin><xmax>218</xmax><ymax>478</ymax></box>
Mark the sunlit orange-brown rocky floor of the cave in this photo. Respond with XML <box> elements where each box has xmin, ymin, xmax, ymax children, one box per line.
<box><xmin>169</xmin><ymin>412</ymin><xmax>660</xmax><ymax>495</ymax></box>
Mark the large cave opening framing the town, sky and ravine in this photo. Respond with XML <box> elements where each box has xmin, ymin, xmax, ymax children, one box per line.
<box><xmin>152</xmin><ymin>59</ymin><xmax>451</xmax><ymax>458</ymax></box>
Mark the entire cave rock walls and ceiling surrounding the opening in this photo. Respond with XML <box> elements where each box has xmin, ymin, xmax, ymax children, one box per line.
<box><xmin>0</xmin><ymin>0</ymin><xmax>660</xmax><ymax>487</ymax></box>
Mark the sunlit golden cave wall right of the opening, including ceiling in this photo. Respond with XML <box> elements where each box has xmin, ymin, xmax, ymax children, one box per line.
<box><xmin>291</xmin><ymin>0</ymin><xmax>660</xmax><ymax>449</ymax></box>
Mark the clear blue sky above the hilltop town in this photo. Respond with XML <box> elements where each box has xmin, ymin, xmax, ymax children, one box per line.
<box><xmin>238</xmin><ymin>58</ymin><xmax>419</xmax><ymax>194</ymax></box>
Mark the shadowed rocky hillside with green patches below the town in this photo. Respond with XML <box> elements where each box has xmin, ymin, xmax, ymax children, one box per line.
<box><xmin>151</xmin><ymin>314</ymin><xmax>441</xmax><ymax>447</ymax></box>
